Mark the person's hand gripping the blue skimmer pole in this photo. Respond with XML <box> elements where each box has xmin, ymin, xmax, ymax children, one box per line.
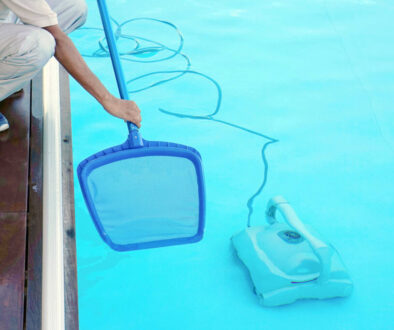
<box><xmin>103</xmin><ymin>96</ymin><xmax>141</xmax><ymax>127</ymax></box>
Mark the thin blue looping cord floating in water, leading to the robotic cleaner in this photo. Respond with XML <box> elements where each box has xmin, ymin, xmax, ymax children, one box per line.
<box><xmin>80</xmin><ymin>17</ymin><xmax>279</xmax><ymax>227</ymax></box>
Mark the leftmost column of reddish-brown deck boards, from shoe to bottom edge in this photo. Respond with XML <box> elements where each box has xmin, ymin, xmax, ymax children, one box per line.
<box><xmin>0</xmin><ymin>84</ymin><xmax>30</xmax><ymax>330</ymax></box>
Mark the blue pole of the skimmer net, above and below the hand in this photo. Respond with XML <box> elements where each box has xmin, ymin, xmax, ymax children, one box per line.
<box><xmin>97</xmin><ymin>0</ymin><xmax>142</xmax><ymax>146</ymax></box>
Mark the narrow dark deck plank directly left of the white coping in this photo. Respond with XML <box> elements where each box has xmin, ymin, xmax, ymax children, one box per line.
<box><xmin>25</xmin><ymin>73</ymin><xmax>43</xmax><ymax>330</ymax></box>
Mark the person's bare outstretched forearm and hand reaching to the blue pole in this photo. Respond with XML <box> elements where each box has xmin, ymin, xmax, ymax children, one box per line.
<box><xmin>44</xmin><ymin>25</ymin><xmax>141</xmax><ymax>127</ymax></box>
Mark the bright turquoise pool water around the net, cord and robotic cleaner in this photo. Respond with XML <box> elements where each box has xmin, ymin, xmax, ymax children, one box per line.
<box><xmin>71</xmin><ymin>0</ymin><xmax>394</xmax><ymax>330</ymax></box>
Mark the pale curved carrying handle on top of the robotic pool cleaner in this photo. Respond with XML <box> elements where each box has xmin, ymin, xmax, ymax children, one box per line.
<box><xmin>266</xmin><ymin>196</ymin><xmax>333</xmax><ymax>281</ymax></box>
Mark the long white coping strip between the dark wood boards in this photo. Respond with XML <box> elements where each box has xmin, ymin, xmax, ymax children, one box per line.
<box><xmin>41</xmin><ymin>58</ymin><xmax>65</xmax><ymax>330</ymax></box>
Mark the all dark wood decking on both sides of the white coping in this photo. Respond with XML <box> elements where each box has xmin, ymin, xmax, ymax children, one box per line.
<box><xmin>0</xmin><ymin>65</ymin><xmax>78</xmax><ymax>330</ymax></box>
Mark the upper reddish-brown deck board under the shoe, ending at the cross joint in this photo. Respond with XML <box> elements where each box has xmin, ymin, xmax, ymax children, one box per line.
<box><xmin>0</xmin><ymin>84</ymin><xmax>30</xmax><ymax>212</ymax></box>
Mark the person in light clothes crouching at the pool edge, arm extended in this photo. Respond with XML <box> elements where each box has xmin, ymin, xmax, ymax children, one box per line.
<box><xmin>0</xmin><ymin>0</ymin><xmax>141</xmax><ymax>132</ymax></box>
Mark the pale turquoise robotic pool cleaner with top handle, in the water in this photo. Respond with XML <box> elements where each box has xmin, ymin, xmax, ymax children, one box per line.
<box><xmin>232</xmin><ymin>196</ymin><xmax>353</xmax><ymax>306</ymax></box>
